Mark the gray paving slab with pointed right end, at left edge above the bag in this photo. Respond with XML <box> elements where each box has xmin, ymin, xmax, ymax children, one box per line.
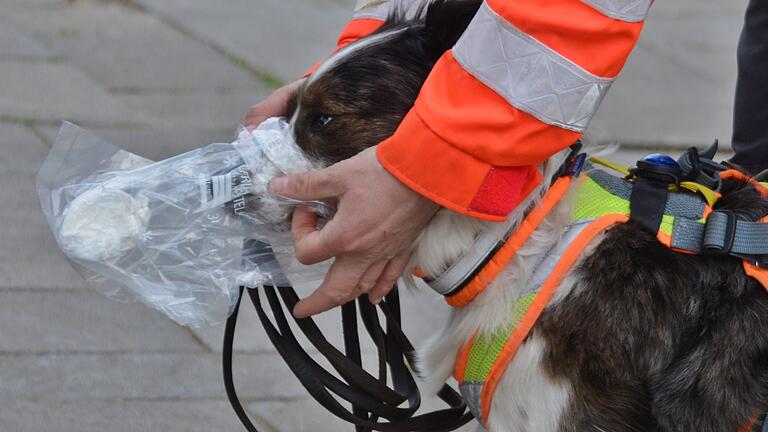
<box><xmin>0</xmin><ymin>60</ymin><xmax>142</xmax><ymax>124</ymax></box>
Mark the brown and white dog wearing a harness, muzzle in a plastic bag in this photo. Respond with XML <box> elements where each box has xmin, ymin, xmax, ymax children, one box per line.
<box><xmin>282</xmin><ymin>0</ymin><xmax>768</xmax><ymax>432</ymax></box>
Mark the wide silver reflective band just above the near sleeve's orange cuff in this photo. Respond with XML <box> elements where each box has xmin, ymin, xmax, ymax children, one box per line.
<box><xmin>453</xmin><ymin>3</ymin><xmax>613</xmax><ymax>132</ymax></box>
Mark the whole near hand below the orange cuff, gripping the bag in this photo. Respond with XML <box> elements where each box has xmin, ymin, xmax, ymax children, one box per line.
<box><xmin>271</xmin><ymin>147</ymin><xmax>439</xmax><ymax>318</ymax></box>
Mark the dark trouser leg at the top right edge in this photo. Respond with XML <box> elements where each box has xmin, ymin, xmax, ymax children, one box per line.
<box><xmin>732</xmin><ymin>0</ymin><xmax>768</xmax><ymax>174</ymax></box>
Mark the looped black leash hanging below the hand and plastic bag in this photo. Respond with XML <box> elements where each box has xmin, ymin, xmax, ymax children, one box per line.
<box><xmin>223</xmin><ymin>286</ymin><xmax>472</xmax><ymax>432</ymax></box>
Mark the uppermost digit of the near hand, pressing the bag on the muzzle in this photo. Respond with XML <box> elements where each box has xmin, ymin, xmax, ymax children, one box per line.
<box><xmin>269</xmin><ymin>168</ymin><xmax>344</xmax><ymax>201</ymax></box>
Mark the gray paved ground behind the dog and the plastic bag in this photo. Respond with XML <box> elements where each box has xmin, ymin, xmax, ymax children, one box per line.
<box><xmin>0</xmin><ymin>0</ymin><xmax>745</xmax><ymax>432</ymax></box>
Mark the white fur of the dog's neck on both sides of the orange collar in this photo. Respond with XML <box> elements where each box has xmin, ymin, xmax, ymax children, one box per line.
<box><xmin>403</xmin><ymin>150</ymin><xmax>570</xmax><ymax>392</ymax></box>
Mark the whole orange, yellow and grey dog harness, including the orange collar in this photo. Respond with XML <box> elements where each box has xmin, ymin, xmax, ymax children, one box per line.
<box><xmin>428</xmin><ymin>150</ymin><xmax>768</xmax><ymax>430</ymax></box>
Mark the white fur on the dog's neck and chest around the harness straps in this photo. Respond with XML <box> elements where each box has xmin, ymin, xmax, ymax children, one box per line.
<box><xmin>405</xmin><ymin>151</ymin><xmax>599</xmax><ymax>432</ymax></box>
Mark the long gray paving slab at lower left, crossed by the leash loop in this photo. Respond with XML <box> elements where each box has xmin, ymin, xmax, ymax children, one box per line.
<box><xmin>0</xmin><ymin>353</ymin><xmax>306</xmax><ymax>401</ymax></box>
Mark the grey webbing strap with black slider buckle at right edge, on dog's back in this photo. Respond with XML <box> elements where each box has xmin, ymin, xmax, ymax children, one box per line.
<box><xmin>672</xmin><ymin>211</ymin><xmax>768</xmax><ymax>257</ymax></box>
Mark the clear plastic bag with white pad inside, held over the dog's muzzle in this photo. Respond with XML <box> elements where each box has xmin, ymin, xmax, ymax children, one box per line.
<box><xmin>37</xmin><ymin>119</ymin><xmax>332</xmax><ymax>327</ymax></box>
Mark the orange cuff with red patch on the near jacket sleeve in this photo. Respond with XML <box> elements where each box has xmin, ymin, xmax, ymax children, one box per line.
<box><xmin>377</xmin><ymin>109</ymin><xmax>541</xmax><ymax>222</ymax></box>
